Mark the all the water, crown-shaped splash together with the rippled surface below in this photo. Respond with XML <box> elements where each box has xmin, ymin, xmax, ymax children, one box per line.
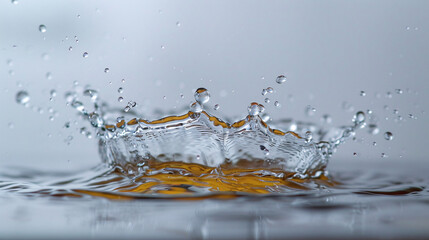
<box><xmin>0</xmin><ymin>88</ymin><xmax>429</xmax><ymax>239</ymax></box>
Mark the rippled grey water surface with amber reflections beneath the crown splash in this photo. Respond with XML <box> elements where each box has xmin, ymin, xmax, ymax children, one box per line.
<box><xmin>0</xmin><ymin>159</ymin><xmax>429</xmax><ymax>239</ymax></box>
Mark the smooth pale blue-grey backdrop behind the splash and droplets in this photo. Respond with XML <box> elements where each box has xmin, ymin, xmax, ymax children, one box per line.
<box><xmin>0</xmin><ymin>0</ymin><xmax>429</xmax><ymax>170</ymax></box>
